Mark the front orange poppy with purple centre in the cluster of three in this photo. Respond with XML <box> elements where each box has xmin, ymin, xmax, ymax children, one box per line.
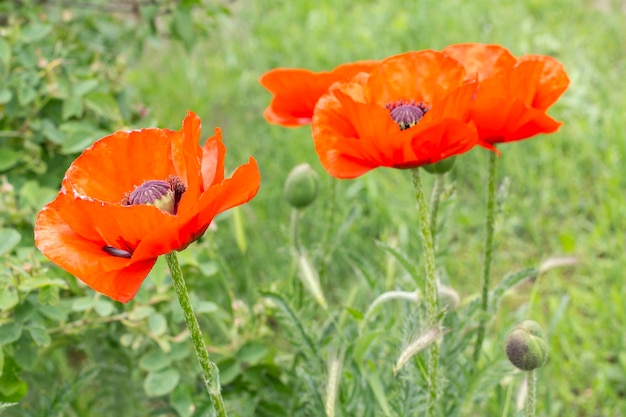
<box><xmin>312</xmin><ymin>50</ymin><xmax>478</xmax><ymax>178</ymax></box>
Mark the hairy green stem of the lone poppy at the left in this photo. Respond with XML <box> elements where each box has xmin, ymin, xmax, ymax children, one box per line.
<box><xmin>165</xmin><ymin>252</ymin><xmax>227</xmax><ymax>417</ymax></box>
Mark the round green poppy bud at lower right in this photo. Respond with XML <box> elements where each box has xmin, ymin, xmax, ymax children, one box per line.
<box><xmin>505</xmin><ymin>320</ymin><xmax>548</xmax><ymax>371</ymax></box>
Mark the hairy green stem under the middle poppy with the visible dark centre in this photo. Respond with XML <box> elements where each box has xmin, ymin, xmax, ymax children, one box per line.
<box><xmin>411</xmin><ymin>168</ymin><xmax>439</xmax><ymax>416</ymax></box>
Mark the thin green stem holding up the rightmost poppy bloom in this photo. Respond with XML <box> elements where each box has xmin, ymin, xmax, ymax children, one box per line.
<box><xmin>474</xmin><ymin>152</ymin><xmax>497</xmax><ymax>363</ymax></box>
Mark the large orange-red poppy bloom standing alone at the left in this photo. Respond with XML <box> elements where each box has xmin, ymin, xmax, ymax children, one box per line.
<box><xmin>35</xmin><ymin>112</ymin><xmax>260</xmax><ymax>302</ymax></box>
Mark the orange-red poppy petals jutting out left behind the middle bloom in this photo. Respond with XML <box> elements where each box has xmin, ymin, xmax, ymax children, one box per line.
<box><xmin>259</xmin><ymin>61</ymin><xmax>377</xmax><ymax>127</ymax></box>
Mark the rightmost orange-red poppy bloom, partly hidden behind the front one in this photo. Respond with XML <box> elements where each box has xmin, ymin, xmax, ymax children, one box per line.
<box><xmin>443</xmin><ymin>43</ymin><xmax>569</xmax><ymax>144</ymax></box>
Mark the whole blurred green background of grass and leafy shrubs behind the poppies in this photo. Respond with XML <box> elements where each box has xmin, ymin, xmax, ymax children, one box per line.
<box><xmin>0</xmin><ymin>0</ymin><xmax>626</xmax><ymax>416</ymax></box>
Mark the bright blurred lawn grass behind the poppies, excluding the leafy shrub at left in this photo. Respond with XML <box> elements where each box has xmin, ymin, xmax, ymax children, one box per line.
<box><xmin>120</xmin><ymin>0</ymin><xmax>626</xmax><ymax>416</ymax></box>
